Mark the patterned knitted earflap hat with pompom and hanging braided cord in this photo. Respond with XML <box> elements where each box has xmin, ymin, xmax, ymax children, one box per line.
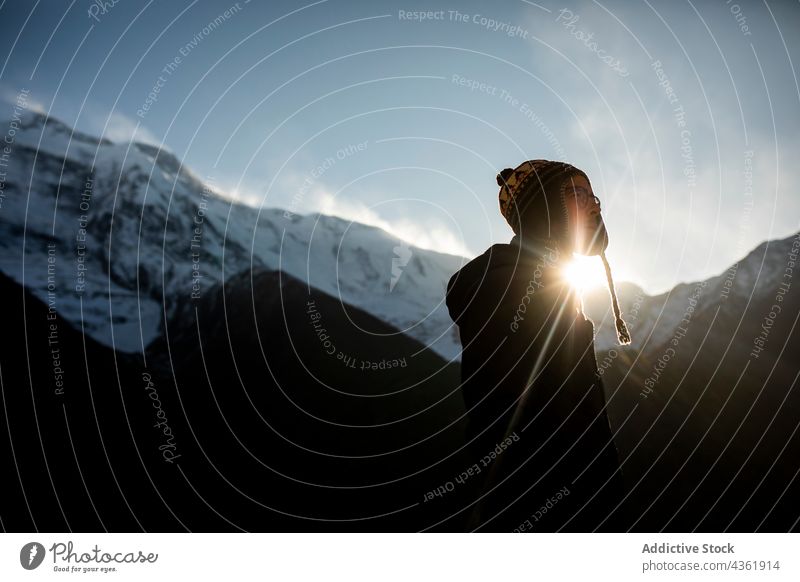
<box><xmin>497</xmin><ymin>160</ymin><xmax>631</xmax><ymax>345</ymax></box>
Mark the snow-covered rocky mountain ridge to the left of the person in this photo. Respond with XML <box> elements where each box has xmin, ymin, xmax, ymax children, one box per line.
<box><xmin>0</xmin><ymin>111</ymin><xmax>466</xmax><ymax>359</ymax></box>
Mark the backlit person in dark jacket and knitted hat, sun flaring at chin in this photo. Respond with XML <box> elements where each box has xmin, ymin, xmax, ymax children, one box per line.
<box><xmin>447</xmin><ymin>160</ymin><xmax>630</xmax><ymax>531</ymax></box>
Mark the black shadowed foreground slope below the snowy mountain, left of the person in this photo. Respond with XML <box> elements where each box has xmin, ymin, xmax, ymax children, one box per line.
<box><xmin>0</xmin><ymin>272</ymin><xmax>466</xmax><ymax>531</ymax></box>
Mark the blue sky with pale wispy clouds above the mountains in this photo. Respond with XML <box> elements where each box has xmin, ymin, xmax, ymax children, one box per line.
<box><xmin>0</xmin><ymin>0</ymin><xmax>800</xmax><ymax>293</ymax></box>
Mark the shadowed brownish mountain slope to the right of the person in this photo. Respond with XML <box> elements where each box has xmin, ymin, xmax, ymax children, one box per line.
<box><xmin>598</xmin><ymin>270</ymin><xmax>800</xmax><ymax>531</ymax></box>
